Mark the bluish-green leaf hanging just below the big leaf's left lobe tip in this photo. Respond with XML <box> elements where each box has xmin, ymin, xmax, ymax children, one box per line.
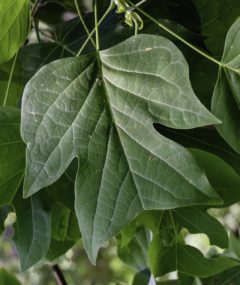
<box><xmin>13</xmin><ymin>192</ymin><xmax>51</xmax><ymax>271</ymax></box>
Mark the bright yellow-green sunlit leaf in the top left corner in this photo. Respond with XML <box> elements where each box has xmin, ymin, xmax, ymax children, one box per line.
<box><xmin>0</xmin><ymin>0</ymin><xmax>30</xmax><ymax>63</ymax></box>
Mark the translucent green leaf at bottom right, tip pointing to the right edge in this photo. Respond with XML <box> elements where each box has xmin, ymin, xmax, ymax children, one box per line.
<box><xmin>149</xmin><ymin>234</ymin><xmax>239</xmax><ymax>278</ymax></box>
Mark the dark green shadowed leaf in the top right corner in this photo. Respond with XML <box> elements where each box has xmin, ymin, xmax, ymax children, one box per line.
<box><xmin>193</xmin><ymin>0</ymin><xmax>240</xmax><ymax>56</ymax></box>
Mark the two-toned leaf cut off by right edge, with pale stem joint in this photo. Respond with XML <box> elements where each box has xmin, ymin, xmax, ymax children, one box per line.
<box><xmin>212</xmin><ymin>18</ymin><xmax>240</xmax><ymax>153</ymax></box>
